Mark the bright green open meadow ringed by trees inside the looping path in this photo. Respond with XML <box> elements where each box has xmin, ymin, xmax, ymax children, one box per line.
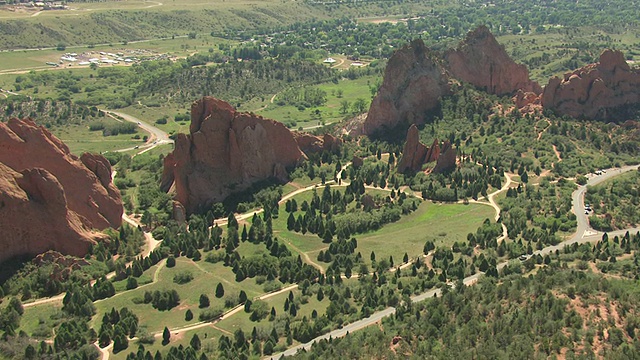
<box><xmin>355</xmin><ymin>201</ymin><xmax>495</xmax><ymax>265</ymax></box>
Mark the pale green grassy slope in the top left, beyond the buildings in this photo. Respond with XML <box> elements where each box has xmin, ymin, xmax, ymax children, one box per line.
<box><xmin>0</xmin><ymin>0</ymin><xmax>330</xmax><ymax>49</ymax></box>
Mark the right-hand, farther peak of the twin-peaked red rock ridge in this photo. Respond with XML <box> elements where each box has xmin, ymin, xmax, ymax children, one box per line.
<box><xmin>444</xmin><ymin>26</ymin><xmax>542</xmax><ymax>95</ymax></box>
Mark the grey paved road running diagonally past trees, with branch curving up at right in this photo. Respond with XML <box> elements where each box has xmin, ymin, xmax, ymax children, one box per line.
<box><xmin>266</xmin><ymin>165</ymin><xmax>640</xmax><ymax>360</ymax></box>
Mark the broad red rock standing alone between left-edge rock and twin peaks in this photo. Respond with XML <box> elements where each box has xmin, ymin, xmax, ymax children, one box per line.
<box><xmin>161</xmin><ymin>97</ymin><xmax>305</xmax><ymax>214</ymax></box>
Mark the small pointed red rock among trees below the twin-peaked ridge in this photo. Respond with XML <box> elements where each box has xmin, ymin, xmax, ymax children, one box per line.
<box><xmin>398</xmin><ymin>125</ymin><xmax>456</xmax><ymax>173</ymax></box>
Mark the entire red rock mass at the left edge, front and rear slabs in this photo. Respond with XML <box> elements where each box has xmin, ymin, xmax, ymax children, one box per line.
<box><xmin>0</xmin><ymin>119</ymin><xmax>123</xmax><ymax>261</ymax></box>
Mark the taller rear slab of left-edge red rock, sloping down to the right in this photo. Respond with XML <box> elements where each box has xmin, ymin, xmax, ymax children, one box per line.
<box><xmin>0</xmin><ymin>119</ymin><xmax>123</xmax><ymax>230</ymax></box>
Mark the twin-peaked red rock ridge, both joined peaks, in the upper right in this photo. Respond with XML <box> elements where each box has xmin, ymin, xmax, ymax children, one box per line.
<box><xmin>360</xmin><ymin>26</ymin><xmax>542</xmax><ymax>135</ymax></box>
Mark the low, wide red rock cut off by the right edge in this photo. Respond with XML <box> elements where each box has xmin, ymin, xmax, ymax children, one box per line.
<box><xmin>542</xmin><ymin>50</ymin><xmax>640</xmax><ymax>120</ymax></box>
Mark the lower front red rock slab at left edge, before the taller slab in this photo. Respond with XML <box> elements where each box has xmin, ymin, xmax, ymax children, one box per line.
<box><xmin>0</xmin><ymin>162</ymin><xmax>106</xmax><ymax>262</ymax></box>
